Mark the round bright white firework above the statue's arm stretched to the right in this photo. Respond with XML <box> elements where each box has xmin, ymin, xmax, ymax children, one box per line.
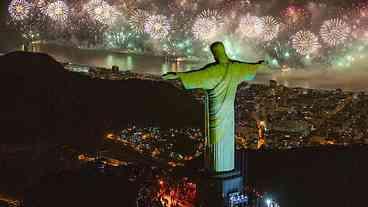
<box><xmin>238</xmin><ymin>13</ymin><xmax>264</xmax><ymax>38</ymax></box>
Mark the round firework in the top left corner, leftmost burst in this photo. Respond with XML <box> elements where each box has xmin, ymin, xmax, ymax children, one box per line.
<box><xmin>8</xmin><ymin>0</ymin><xmax>32</xmax><ymax>21</ymax></box>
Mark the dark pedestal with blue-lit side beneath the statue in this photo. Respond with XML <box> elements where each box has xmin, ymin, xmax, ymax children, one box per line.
<box><xmin>197</xmin><ymin>171</ymin><xmax>247</xmax><ymax>207</ymax></box>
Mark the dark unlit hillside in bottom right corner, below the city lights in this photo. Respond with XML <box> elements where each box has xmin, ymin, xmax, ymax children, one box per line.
<box><xmin>244</xmin><ymin>145</ymin><xmax>368</xmax><ymax>207</ymax></box>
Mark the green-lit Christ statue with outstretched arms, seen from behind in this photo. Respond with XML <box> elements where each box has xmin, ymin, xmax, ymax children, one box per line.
<box><xmin>163</xmin><ymin>42</ymin><xmax>264</xmax><ymax>173</ymax></box>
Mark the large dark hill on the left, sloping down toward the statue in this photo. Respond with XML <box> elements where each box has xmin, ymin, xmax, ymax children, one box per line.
<box><xmin>0</xmin><ymin>52</ymin><xmax>203</xmax><ymax>145</ymax></box>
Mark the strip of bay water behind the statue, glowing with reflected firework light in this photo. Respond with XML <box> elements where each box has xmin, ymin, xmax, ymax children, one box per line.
<box><xmin>9</xmin><ymin>42</ymin><xmax>368</xmax><ymax>92</ymax></box>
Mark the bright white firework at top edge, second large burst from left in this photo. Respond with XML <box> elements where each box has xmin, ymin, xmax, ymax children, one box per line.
<box><xmin>46</xmin><ymin>1</ymin><xmax>69</xmax><ymax>24</ymax></box>
